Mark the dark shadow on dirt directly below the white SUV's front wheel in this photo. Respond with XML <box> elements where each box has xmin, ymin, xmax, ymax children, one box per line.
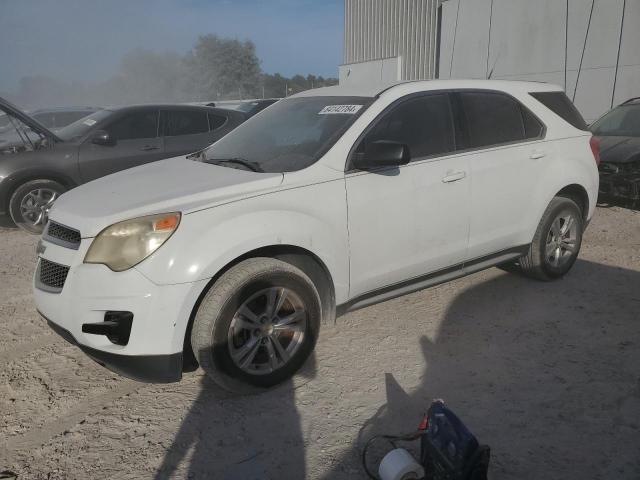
<box><xmin>155</xmin><ymin>354</ymin><xmax>316</xmax><ymax>480</ymax></box>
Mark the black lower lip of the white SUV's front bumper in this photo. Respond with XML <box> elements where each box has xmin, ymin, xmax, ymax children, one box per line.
<box><xmin>43</xmin><ymin>312</ymin><xmax>182</xmax><ymax>383</ymax></box>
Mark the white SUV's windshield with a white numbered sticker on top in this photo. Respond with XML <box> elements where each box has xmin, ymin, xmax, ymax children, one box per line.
<box><xmin>203</xmin><ymin>97</ymin><xmax>373</xmax><ymax>173</ymax></box>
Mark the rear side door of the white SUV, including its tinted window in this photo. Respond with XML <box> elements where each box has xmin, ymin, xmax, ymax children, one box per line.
<box><xmin>456</xmin><ymin>91</ymin><xmax>548</xmax><ymax>260</ymax></box>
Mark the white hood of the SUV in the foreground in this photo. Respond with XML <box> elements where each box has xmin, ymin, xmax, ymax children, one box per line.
<box><xmin>50</xmin><ymin>157</ymin><xmax>283</xmax><ymax>238</ymax></box>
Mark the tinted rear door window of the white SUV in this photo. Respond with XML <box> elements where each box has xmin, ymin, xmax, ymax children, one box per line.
<box><xmin>460</xmin><ymin>92</ymin><xmax>528</xmax><ymax>148</ymax></box>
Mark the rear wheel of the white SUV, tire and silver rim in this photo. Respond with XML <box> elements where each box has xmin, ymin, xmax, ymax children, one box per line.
<box><xmin>519</xmin><ymin>197</ymin><xmax>584</xmax><ymax>281</ymax></box>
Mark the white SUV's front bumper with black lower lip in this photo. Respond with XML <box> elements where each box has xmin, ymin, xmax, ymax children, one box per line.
<box><xmin>33</xmin><ymin>239</ymin><xmax>206</xmax><ymax>382</ymax></box>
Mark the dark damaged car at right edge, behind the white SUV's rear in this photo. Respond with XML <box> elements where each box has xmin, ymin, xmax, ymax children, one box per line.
<box><xmin>591</xmin><ymin>97</ymin><xmax>640</xmax><ymax>208</ymax></box>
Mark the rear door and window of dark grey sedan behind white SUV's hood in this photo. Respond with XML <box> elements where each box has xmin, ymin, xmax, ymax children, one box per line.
<box><xmin>162</xmin><ymin>109</ymin><xmax>238</xmax><ymax>157</ymax></box>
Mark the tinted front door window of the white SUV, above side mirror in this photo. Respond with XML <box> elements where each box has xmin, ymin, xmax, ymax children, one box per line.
<box><xmin>361</xmin><ymin>94</ymin><xmax>455</xmax><ymax>160</ymax></box>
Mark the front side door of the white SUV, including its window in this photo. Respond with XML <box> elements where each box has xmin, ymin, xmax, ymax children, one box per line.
<box><xmin>346</xmin><ymin>93</ymin><xmax>470</xmax><ymax>298</ymax></box>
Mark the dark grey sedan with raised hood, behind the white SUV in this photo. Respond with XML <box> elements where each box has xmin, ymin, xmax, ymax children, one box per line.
<box><xmin>0</xmin><ymin>99</ymin><xmax>246</xmax><ymax>233</ymax></box>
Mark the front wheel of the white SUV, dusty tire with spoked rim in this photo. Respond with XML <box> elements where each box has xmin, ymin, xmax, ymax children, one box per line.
<box><xmin>191</xmin><ymin>258</ymin><xmax>322</xmax><ymax>394</ymax></box>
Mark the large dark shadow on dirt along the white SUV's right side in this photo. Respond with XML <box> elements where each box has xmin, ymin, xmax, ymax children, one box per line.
<box><xmin>322</xmin><ymin>260</ymin><xmax>640</xmax><ymax>480</ymax></box>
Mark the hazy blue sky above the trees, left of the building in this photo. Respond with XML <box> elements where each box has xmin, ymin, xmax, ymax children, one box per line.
<box><xmin>0</xmin><ymin>0</ymin><xmax>344</xmax><ymax>91</ymax></box>
